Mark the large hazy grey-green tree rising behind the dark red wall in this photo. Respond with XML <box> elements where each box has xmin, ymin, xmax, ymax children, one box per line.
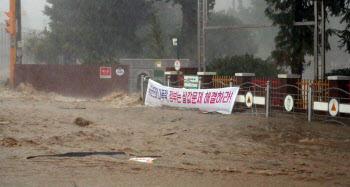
<box><xmin>32</xmin><ymin>0</ymin><xmax>152</xmax><ymax>64</ymax></box>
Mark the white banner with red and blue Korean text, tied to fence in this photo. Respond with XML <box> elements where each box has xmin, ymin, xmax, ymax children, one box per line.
<box><xmin>145</xmin><ymin>79</ymin><xmax>239</xmax><ymax>114</ymax></box>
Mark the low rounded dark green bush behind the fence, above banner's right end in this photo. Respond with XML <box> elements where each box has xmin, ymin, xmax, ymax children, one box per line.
<box><xmin>207</xmin><ymin>54</ymin><xmax>283</xmax><ymax>77</ymax></box>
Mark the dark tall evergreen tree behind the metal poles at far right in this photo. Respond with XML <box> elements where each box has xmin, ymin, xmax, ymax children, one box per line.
<box><xmin>265</xmin><ymin>0</ymin><xmax>350</xmax><ymax>75</ymax></box>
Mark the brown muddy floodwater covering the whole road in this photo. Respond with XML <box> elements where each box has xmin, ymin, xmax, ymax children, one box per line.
<box><xmin>0</xmin><ymin>82</ymin><xmax>350</xmax><ymax>186</ymax></box>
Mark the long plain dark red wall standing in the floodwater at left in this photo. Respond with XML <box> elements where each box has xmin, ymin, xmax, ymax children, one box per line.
<box><xmin>15</xmin><ymin>64</ymin><xmax>129</xmax><ymax>98</ymax></box>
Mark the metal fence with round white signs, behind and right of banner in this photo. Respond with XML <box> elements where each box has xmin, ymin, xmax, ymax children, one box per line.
<box><xmin>141</xmin><ymin>77</ymin><xmax>350</xmax><ymax>124</ymax></box>
